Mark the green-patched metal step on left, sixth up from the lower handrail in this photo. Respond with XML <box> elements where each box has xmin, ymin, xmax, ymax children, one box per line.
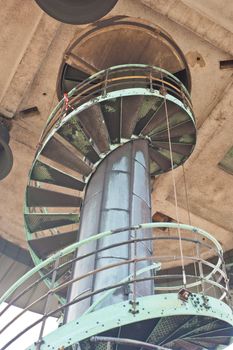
<box><xmin>58</xmin><ymin>116</ymin><xmax>99</xmax><ymax>164</ymax></box>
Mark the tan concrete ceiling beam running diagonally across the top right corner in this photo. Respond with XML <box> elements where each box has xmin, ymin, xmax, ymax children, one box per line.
<box><xmin>141</xmin><ymin>0</ymin><xmax>233</xmax><ymax>56</ymax></box>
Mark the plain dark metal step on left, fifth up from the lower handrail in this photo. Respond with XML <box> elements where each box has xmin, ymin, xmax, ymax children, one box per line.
<box><xmin>42</xmin><ymin>137</ymin><xmax>92</xmax><ymax>176</ymax></box>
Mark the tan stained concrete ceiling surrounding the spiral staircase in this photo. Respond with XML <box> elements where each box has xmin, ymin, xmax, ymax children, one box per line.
<box><xmin>0</xmin><ymin>0</ymin><xmax>233</xmax><ymax>249</ymax></box>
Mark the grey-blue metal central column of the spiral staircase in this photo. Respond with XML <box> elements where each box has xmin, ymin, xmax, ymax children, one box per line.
<box><xmin>65</xmin><ymin>140</ymin><xmax>153</xmax><ymax>322</ymax></box>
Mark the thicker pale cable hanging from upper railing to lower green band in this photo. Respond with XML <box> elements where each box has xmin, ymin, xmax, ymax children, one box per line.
<box><xmin>160</xmin><ymin>67</ymin><xmax>187</xmax><ymax>286</ymax></box>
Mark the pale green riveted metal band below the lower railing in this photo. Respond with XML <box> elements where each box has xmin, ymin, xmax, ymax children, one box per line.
<box><xmin>27</xmin><ymin>293</ymin><xmax>233</xmax><ymax>350</ymax></box>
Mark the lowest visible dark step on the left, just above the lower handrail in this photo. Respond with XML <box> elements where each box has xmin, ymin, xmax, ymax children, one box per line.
<box><xmin>28</xmin><ymin>230</ymin><xmax>78</xmax><ymax>259</ymax></box>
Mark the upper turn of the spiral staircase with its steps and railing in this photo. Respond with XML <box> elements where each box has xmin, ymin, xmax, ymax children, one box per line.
<box><xmin>25</xmin><ymin>65</ymin><xmax>196</xmax><ymax>266</ymax></box>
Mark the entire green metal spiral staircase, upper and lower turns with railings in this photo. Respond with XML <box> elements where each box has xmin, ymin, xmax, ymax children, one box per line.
<box><xmin>1</xmin><ymin>19</ymin><xmax>233</xmax><ymax>350</ymax></box>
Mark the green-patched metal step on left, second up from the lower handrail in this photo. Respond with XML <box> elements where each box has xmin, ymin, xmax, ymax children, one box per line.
<box><xmin>24</xmin><ymin>213</ymin><xmax>79</xmax><ymax>233</ymax></box>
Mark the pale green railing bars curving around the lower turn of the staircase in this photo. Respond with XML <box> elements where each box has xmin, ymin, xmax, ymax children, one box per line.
<box><xmin>0</xmin><ymin>223</ymin><xmax>229</xmax><ymax>349</ymax></box>
